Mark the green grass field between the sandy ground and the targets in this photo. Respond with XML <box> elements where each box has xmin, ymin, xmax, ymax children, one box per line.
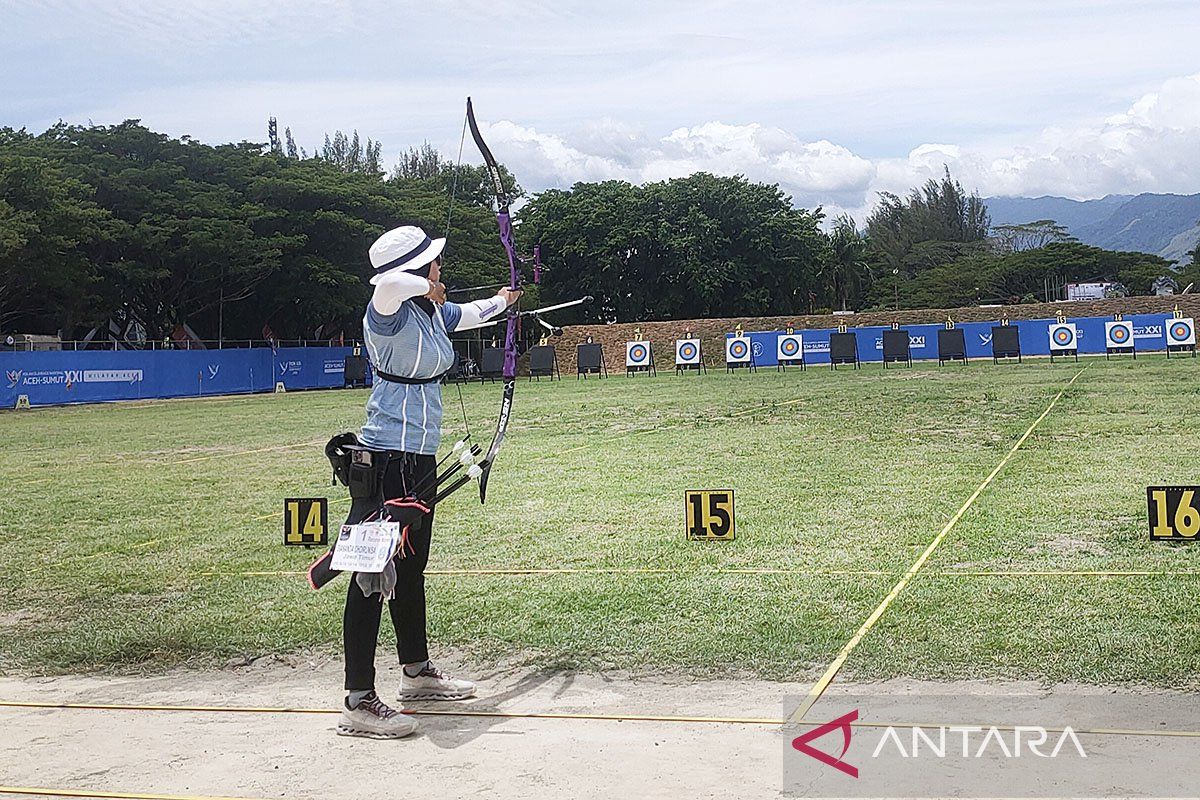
<box><xmin>0</xmin><ymin>357</ymin><xmax>1200</xmax><ymax>686</ymax></box>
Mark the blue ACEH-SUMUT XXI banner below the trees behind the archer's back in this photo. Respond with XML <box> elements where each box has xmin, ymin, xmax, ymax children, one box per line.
<box><xmin>0</xmin><ymin>347</ymin><xmax>352</xmax><ymax>408</ymax></box>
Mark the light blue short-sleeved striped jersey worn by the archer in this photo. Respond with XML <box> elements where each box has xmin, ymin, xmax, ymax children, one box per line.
<box><xmin>359</xmin><ymin>300</ymin><xmax>462</xmax><ymax>456</ymax></box>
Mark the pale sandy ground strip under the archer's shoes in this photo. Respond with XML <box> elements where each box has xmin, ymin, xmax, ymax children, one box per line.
<box><xmin>0</xmin><ymin>657</ymin><xmax>1200</xmax><ymax>799</ymax></box>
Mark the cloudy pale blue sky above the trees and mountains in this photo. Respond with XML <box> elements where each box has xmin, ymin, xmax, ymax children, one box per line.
<box><xmin>7</xmin><ymin>0</ymin><xmax>1200</xmax><ymax>216</ymax></box>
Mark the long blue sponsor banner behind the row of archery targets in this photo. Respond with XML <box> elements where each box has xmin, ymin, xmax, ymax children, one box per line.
<box><xmin>726</xmin><ymin>314</ymin><xmax>1170</xmax><ymax>367</ymax></box>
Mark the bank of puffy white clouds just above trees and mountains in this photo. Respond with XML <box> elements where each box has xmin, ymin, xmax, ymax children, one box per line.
<box><xmin>465</xmin><ymin>74</ymin><xmax>1200</xmax><ymax>218</ymax></box>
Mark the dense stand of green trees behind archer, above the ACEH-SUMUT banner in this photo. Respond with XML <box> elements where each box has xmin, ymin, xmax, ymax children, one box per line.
<box><xmin>0</xmin><ymin>120</ymin><xmax>530</xmax><ymax>339</ymax></box>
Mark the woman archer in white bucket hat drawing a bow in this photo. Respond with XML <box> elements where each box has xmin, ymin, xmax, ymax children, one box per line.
<box><xmin>338</xmin><ymin>225</ymin><xmax>521</xmax><ymax>739</ymax></box>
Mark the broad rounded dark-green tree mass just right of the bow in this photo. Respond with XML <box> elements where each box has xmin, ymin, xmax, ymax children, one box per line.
<box><xmin>518</xmin><ymin>173</ymin><xmax>828</xmax><ymax>320</ymax></box>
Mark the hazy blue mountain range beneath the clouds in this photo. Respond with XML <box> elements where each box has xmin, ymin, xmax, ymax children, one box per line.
<box><xmin>984</xmin><ymin>193</ymin><xmax>1200</xmax><ymax>265</ymax></box>
